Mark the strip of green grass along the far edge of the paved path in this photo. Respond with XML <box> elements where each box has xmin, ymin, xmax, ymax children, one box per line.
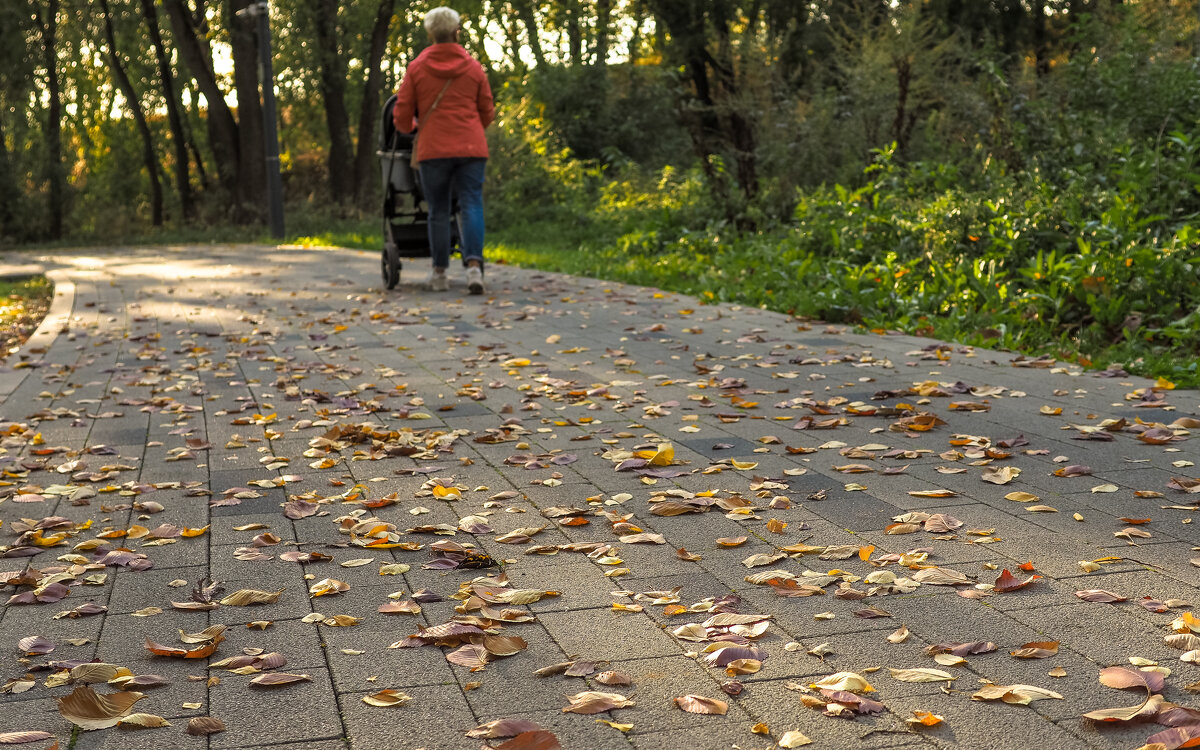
<box><xmin>11</xmin><ymin>210</ymin><xmax>1200</xmax><ymax>388</ymax></box>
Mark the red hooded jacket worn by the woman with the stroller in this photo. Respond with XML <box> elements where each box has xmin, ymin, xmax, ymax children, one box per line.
<box><xmin>392</xmin><ymin>42</ymin><xmax>496</xmax><ymax>161</ymax></box>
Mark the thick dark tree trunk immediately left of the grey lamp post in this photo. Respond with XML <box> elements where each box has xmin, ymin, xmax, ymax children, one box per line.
<box><xmin>226</xmin><ymin>0</ymin><xmax>264</xmax><ymax>221</ymax></box>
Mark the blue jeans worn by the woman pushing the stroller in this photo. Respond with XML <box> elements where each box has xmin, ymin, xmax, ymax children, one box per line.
<box><xmin>420</xmin><ymin>158</ymin><xmax>487</xmax><ymax>269</ymax></box>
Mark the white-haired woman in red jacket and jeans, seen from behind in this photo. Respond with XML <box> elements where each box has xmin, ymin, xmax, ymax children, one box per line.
<box><xmin>392</xmin><ymin>7</ymin><xmax>496</xmax><ymax>294</ymax></box>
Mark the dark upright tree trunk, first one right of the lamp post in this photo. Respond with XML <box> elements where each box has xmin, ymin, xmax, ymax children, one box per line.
<box><xmin>309</xmin><ymin>0</ymin><xmax>355</xmax><ymax>203</ymax></box>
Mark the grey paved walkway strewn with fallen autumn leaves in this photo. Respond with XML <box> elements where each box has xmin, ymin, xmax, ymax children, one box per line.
<box><xmin>0</xmin><ymin>247</ymin><xmax>1200</xmax><ymax>750</ymax></box>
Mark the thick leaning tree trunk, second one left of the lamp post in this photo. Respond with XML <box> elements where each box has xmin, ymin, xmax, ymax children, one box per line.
<box><xmin>163</xmin><ymin>0</ymin><xmax>239</xmax><ymax>202</ymax></box>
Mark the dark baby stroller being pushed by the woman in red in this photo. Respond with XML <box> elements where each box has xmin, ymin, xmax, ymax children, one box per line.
<box><xmin>376</xmin><ymin>95</ymin><xmax>458</xmax><ymax>289</ymax></box>
